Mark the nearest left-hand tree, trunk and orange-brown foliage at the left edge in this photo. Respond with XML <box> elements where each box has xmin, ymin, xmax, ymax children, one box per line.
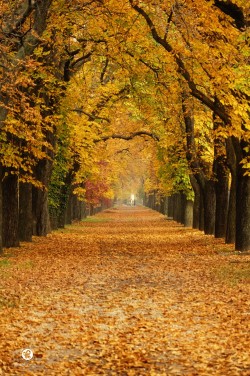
<box><xmin>0</xmin><ymin>0</ymin><xmax>51</xmax><ymax>251</ymax></box>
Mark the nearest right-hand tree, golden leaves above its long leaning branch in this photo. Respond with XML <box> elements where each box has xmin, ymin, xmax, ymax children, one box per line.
<box><xmin>130</xmin><ymin>0</ymin><xmax>250</xmax><ymax>251</ymax></box>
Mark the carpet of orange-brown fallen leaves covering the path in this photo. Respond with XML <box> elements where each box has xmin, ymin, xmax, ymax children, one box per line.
<box><xmin>0</xmin><ymin>206</ymin><xmax>250</xmax><ymax>376</ymax></box>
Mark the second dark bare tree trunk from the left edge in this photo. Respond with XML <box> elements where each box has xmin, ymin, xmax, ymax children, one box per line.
<box><xmin>19</xmin><ymin>183</ymin><xmax>33</xmax><ymax>242</ymax></box>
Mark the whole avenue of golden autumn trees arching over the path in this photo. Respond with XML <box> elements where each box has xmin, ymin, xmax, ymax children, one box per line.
<box><xmin>0</xmin><ymin>0</ymin><xmax>250</xmax><ymax>252</ymax></box>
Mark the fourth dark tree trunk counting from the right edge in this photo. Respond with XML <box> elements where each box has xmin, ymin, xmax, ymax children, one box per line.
<box><xmin>204</xmin><ymin>180</ymin><xmax>216</xmax><ymax>235</ymax></box>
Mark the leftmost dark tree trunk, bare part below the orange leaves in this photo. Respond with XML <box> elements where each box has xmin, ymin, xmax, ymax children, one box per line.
<box><xmin>2</xmin><ymin>170</ymin><xmax>19</xmax><ymax>248</ymax></box>
